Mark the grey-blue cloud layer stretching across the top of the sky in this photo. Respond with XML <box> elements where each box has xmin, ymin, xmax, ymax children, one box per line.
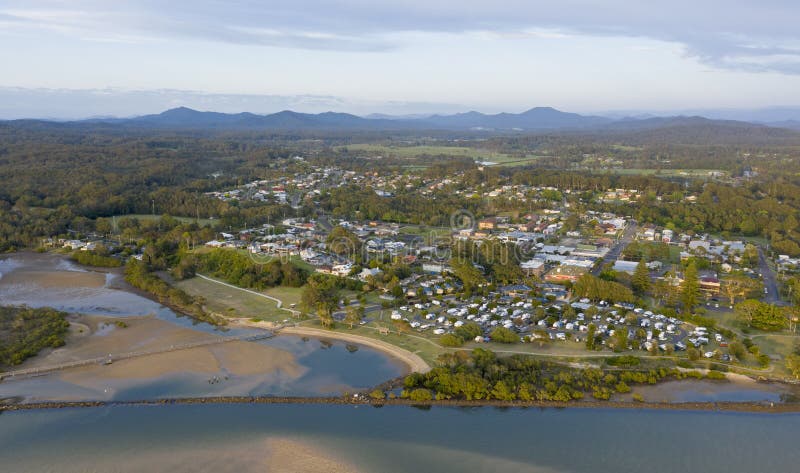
<box><xmin>0</xmin><ymin>0</ymin><xmax>800</xmax><ymax>74</ymax></box>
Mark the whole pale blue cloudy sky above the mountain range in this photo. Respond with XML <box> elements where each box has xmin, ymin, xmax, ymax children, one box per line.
<box><xmin>0</xmin><ymin>0</ymin><xmax>800</xmax><ymax>118</ymax></box>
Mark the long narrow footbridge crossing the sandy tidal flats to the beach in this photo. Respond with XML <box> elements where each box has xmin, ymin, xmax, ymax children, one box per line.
<box><xmin>0</xmin><ymin>331</ymin><xmax>275</xmax><ymax>381</ymax></box>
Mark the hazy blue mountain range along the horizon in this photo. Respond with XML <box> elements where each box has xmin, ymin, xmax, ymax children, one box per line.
<box><xmin>5</xmin><ymin>107</ymin><xmax>800</xmax><ymax>143</ymax></box>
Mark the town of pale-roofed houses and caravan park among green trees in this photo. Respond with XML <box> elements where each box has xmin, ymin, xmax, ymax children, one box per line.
<box><xmin>47</xmin><ymin>156</ymin><xmax>798</xmax><ymax>369</ymax></box>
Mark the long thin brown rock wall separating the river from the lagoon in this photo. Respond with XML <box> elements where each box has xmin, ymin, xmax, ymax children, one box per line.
<box><xmin>0</xmin><ymin>396</ymin><xmax>800</xmax><ymax>414</ymax></box>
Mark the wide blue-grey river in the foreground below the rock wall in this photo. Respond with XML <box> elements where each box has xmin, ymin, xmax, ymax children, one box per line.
<box><xmin>0</xmin><ymin>405</ymin><xmax>800</xmax><ymax>473</ymax></box>
